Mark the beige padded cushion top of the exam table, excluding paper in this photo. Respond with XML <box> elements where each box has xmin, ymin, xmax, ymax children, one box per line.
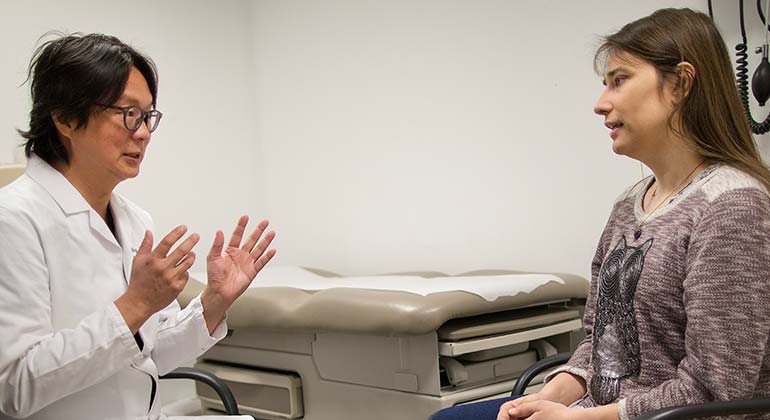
<box><xmin>178</xmin><ymin>269</ymin><xmax>588</xmax><ymax>335</ymax></box>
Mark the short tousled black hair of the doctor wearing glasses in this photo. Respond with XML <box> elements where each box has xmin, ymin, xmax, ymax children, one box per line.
<box><xmin>19</xmin><ymin>33</ymin><xmax>158</xmax><ymax>164</ymax></box>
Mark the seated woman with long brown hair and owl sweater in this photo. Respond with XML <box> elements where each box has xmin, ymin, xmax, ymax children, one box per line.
<box><xmin>434</xmin><ymin>9</ymin><xmax>770</xmax><ymax>420</ymax></box>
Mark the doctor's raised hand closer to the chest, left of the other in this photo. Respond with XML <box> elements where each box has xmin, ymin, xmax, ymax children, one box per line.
<box><xmin>115</xmin><ymin>226</ymin><xmax>200</xmax><ymax>334</ymax></box>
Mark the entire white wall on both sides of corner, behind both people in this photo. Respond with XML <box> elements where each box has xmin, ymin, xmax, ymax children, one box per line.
<box><xmin>6</xmin><ymin>0</ymin><xmax>770</xmax><ymax>275</ymax></box>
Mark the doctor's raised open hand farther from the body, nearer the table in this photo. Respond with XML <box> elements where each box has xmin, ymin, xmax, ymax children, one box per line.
<box><xmin>201</xmin><ymin>216</ymin><xmax>275</xmax><ymax>333</ymax></box>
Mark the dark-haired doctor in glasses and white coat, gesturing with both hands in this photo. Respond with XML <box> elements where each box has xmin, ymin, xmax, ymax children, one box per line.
<box><xmin>0</xmin><ymin>34</ymin><xmax>275</xmax><ymax>420</ymax></box>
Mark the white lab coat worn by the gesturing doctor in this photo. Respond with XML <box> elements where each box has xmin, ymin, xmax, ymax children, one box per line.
<box><xmin>0</xmin><ymin>156</ymin><xmax>227</xmax><ymax>420</ymax></box>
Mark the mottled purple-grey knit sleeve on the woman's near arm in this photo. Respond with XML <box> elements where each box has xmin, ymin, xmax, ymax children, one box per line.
<box><xmin>620</xmin><ymin>188</ymin><xmax>770</xmax><ymax>419</ymax></box>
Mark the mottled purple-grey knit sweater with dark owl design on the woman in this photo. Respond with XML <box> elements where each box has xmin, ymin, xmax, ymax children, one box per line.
<box><xmin>548</xmin><ymin>165</ymin><xmax>770</xmax><ymax>420</ymax></box>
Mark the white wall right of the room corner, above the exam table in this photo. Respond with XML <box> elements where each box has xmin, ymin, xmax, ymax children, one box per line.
<box><xmin>253</xmin><ymin>0</ymin><xmax>706</xmax><ymax>275</ymax></box>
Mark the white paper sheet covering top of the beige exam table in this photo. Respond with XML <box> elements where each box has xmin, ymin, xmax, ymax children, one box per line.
<box><xmin>190</xmin><ymin>266</ymin><xmax>565</xmax><ymax>302</ymax></box>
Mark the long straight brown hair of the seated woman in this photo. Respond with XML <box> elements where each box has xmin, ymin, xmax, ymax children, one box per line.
<box><xmin>594</xmin><ymin>9</ymin><xmax>770</xmax><ymax>191</ymax></box>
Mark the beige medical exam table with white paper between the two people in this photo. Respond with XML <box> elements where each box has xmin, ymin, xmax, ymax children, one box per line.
<box><xmin>179</xmin><ymin>266</ymin><xmax>588</xmax><ymax>420</ymax></box>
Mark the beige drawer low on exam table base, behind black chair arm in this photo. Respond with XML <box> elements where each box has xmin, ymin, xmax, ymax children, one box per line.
<box><xmin>195</xmin><ymin>362</ymin><xmax>304</xmax><ymax>419</ymax></box>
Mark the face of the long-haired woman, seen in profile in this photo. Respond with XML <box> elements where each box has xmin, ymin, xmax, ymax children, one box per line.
<box><xmin>594</xmin><ymin>52</ymin><xmax>674</xmax><ymax>160</ymax></box>
